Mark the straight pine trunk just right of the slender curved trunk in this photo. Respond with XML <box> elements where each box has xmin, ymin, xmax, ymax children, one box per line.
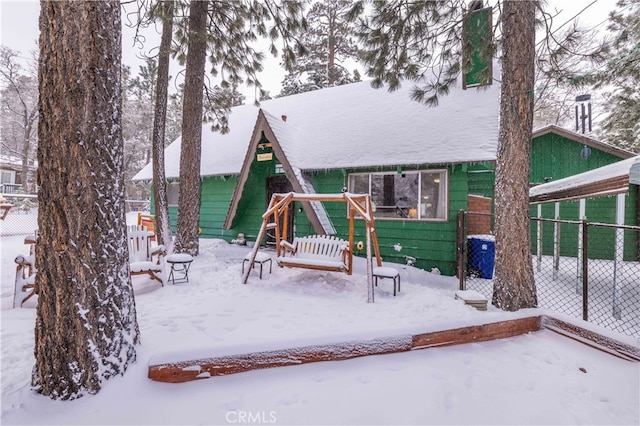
<box><xmin>175</xmin><ymin>0</ymin><xmax>208</xmax><ymax>256</ymax></box>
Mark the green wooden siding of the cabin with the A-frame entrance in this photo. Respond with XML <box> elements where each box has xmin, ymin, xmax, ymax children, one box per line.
<box><xmin>154</xmin><ymin>161</ymin><xmax>484</xmax><ymax>275</ymax></box>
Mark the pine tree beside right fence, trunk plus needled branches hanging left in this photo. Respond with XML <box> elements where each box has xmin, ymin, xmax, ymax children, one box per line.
<box><xmin>350</xmin><ymin>0</ymin><xmax>538</xmax><ymax>311</ymax></box>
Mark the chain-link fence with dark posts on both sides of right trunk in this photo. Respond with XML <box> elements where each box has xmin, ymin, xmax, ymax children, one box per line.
<box><xmin>458</xmin><ymin>212</ymin><xmax>640</xmax><ymax>337</ymax></box>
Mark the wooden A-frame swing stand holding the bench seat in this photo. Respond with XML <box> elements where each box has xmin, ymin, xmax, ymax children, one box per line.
<box><xmin>242</xmin><ymin>192</ymin><xmax>382</xmax><ymax>302</ymax></box>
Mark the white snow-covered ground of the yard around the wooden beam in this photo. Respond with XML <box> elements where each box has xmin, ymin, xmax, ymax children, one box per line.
<box><xmin>0</xmin><ymin>213</ymin><xmax>640</xmax><ymax>425</ymax></box>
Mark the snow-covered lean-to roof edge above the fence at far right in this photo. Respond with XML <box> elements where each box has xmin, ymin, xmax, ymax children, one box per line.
<box><xmin>529</xmin><ymin>155</ymin><xmax>640</xmax><ymax>204</ymax></box>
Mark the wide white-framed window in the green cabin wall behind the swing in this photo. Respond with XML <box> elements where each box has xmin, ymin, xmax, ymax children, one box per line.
<box><xmin>349</xmin><ymin>169</ymin><xmax>448</xmax><ymax>220</ymax></box>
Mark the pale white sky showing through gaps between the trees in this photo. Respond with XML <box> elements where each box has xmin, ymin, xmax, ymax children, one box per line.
<box><xmin>0</xmin><ymin>0</ymin><xmax>616</xmax><ymax>103</ymax></box>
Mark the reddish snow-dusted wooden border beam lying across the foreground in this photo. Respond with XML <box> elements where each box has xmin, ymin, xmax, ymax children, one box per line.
<box><xmin>148</xmin><ymin>315</ymin><xmax>640</xmax><ymax>383</ymax></box>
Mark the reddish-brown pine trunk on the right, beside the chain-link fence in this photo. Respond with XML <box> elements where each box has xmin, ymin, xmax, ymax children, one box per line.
<box><xmin>492</xmin><ymin>1</ymin><xmax>538</xmax><ymax>311</ymax></box>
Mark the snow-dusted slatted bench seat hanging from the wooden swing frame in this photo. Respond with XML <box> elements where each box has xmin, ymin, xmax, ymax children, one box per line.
<box><xmin>276</xmin><ymin>235</ymin><xmax>350</xmax><ymax>272</ymax></box>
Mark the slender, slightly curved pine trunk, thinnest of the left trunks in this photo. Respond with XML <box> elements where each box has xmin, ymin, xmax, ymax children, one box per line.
<box><xmin>151</xmin><ymin>0</ymin><xmax>174</xmax><ymax>253</ymax></box>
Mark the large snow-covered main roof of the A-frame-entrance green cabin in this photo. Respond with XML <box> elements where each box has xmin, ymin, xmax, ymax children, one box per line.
<box><xmin>133</xmin><ymin>77</ymin><xmax>500</xmax><ymax>180</ymax></box>
